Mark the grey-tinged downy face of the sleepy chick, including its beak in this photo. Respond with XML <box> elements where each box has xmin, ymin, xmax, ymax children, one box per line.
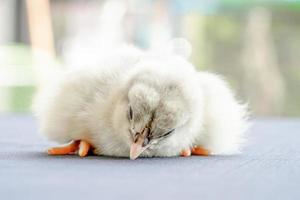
<box><xmin>127</xmin><ymin>83</ymin><xmax>188</xmax><ymax>159</ymax></box>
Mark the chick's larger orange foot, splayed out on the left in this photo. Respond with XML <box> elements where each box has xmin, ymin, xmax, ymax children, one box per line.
<box><xmin>47</xmin><ymin>140</ymin><xmax>92</xmax><ymax>157</ymax></box>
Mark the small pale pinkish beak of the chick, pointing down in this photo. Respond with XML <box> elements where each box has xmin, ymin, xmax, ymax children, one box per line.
<box><xmin>130</xmin><ymin>128</ymin><xmax>148</xmax><ymax>160</ymax></box>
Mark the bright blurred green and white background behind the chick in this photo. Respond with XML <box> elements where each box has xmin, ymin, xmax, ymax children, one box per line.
<box><xmin>0</xmin><ymin>0</ymin><xmax>300</xmax><ymax>117</ymax></box>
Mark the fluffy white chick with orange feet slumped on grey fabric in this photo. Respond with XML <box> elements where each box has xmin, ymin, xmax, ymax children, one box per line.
<box><xmin>35</xmin><ymin>41</ymin><xmax>247</xmax><ymax>159</ymax></box>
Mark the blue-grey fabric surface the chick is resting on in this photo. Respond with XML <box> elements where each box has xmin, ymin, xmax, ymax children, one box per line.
<box><xmin>0</xmin><ymin>115</ymin><xmax>300</xmax><ymax>200</ymax></box>
